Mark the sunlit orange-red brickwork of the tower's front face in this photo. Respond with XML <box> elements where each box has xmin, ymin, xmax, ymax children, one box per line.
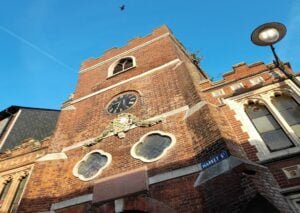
<box><xmin>21</xmin><ymin>28</ymin><xmax>211</xmax><ymax>211</ymax></box>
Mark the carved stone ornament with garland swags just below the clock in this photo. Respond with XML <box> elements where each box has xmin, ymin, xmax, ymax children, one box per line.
<box><xmin>84</xmin><ymin>113</ymin><xmax>163</xmax><ymax>146</ymax></box>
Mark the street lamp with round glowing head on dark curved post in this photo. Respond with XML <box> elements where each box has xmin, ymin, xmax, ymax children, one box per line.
<box><xmin>251</xmin><ymin>22</ymin><xmax>300</xmax><ymax>87</ymax></box>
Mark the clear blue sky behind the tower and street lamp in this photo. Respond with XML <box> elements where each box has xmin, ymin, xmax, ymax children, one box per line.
<box><xmin>0</xmin><ymin>0</ymin><xmax>300</xmax><ymax>110</ymax></box>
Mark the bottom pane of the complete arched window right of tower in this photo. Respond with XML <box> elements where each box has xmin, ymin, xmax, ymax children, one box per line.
<box><xmin>261</xmin><ymin>129</ymin><xmax>293</xmax><ymax>151</ymax></box>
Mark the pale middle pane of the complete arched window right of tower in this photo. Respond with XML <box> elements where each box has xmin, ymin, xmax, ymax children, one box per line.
<box><xmin>252</xmin><ymin>115</ymin><xmax>280</xmax><ymax>133</ymax></box>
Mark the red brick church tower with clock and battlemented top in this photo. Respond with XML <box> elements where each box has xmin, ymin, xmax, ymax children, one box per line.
<box><xmin>15</xmin><ymin>26</ymin><xmax>298</xmax><ymax>213</ymax></box>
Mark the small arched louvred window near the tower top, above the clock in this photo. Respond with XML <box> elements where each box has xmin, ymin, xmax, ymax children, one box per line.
<box><xmin>108</xmin><ymin>56</ymin><xmax>136</xmax><ymax>77</ymax></box>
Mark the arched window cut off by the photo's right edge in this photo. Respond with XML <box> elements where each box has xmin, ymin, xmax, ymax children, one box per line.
<box><xmin>272</xmin><ymin>95</ymin><xmax>300</xmax><ymax>138</ymax></box>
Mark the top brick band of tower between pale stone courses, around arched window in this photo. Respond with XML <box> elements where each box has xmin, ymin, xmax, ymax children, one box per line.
<box><xmin>74</xmin><ymin>37</ymin><xmax>177</xmax><ymax>98</ymax></box>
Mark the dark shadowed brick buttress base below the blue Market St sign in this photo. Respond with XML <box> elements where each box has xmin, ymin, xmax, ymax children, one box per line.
<box><xmin>199</xmin><ymin>164</ymin><xmax>291</xmax><ymax>213</ymax></box>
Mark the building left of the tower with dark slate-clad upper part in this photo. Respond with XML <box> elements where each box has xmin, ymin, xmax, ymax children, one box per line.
<box><xmin>0</xmin><ymin>106</ymin><xmax>59</xmax><ymax>212</ymax></box>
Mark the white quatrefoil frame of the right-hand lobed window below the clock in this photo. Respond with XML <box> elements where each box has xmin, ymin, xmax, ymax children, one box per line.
<box><xmin>130</xmin><ymin>131</ymin><xmax>176</xmax><ymax>163</ymax></box>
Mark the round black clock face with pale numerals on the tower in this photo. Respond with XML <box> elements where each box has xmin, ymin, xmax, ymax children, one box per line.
<box><xmin>107</xmin><ymin>93</ymin><xmax>137</xmax><ymax>114</ymax></box>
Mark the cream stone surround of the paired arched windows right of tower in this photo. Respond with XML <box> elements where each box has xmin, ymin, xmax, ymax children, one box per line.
<box><xmin>224</xmin><ymin>80</ymin><xmax>300</xmax><ymax>160</ymax></box>
